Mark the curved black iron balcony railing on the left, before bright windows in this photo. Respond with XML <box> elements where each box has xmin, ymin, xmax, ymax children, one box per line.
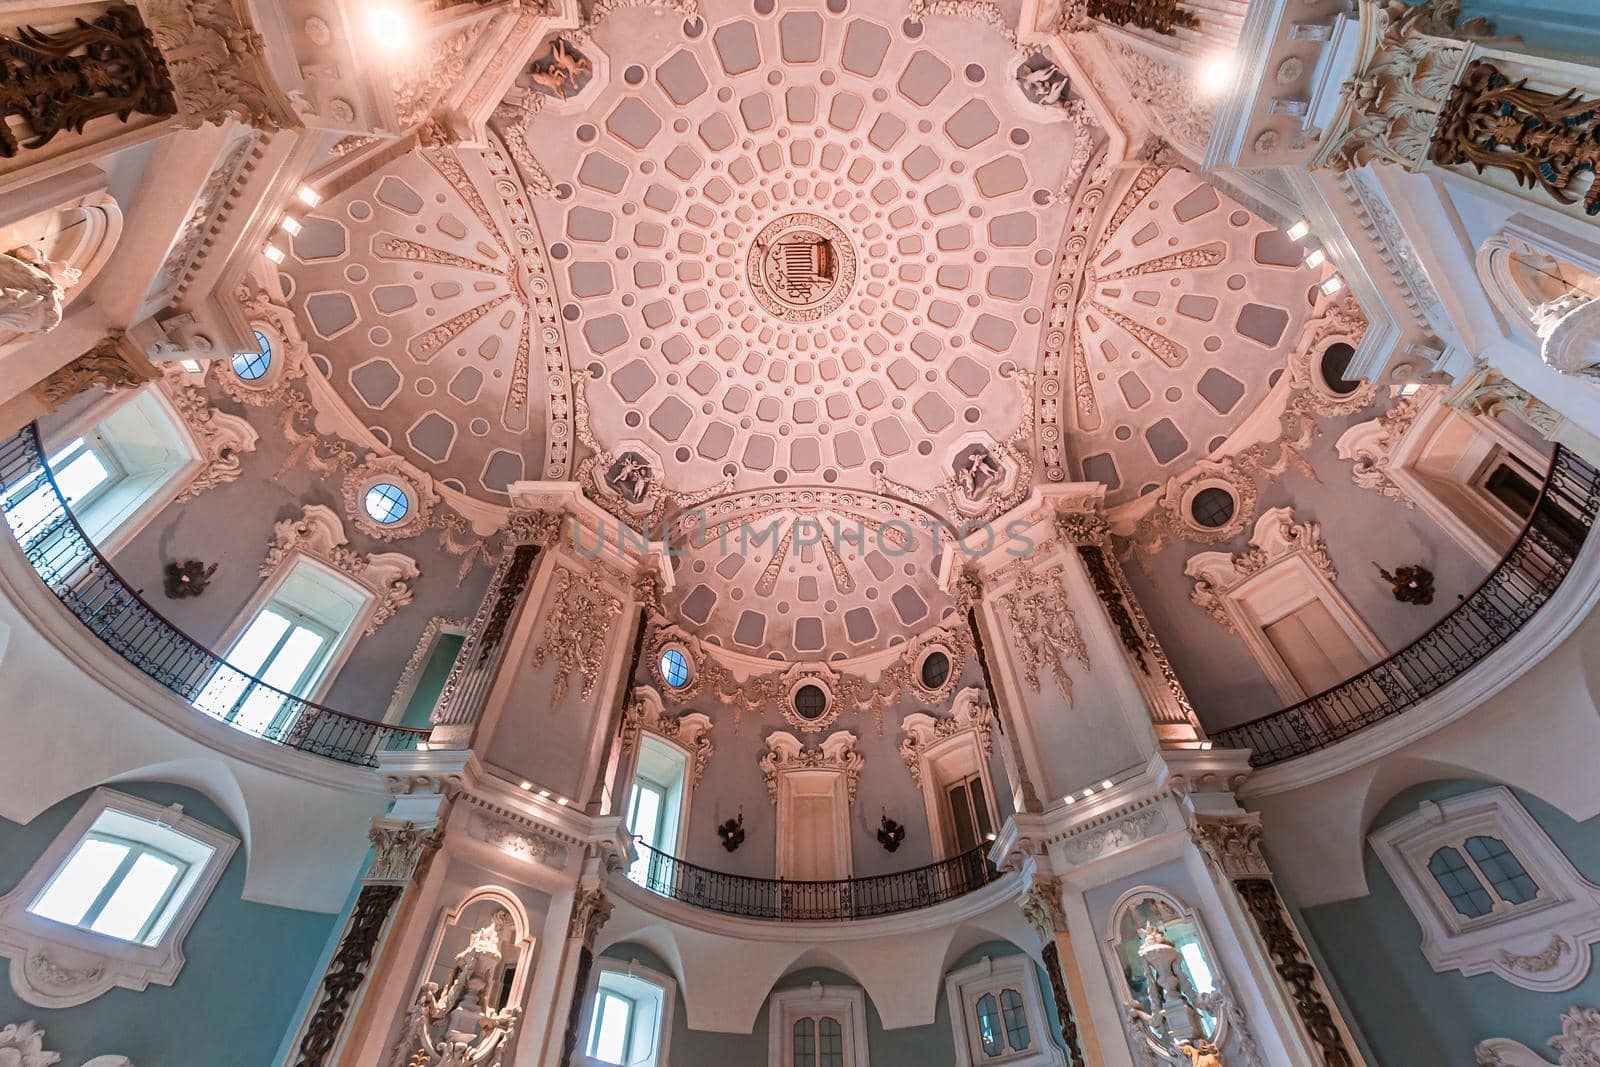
<box><xmin>0</xmin><ymin>426</ymin><xmax>427</xmax><ymax>766</ymax></box>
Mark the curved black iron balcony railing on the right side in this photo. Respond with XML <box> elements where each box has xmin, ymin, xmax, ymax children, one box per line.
<box><xmin>1211</xmin><ymin>446</ymin><xmax>1600</xmax><ymax>766</ymax></box>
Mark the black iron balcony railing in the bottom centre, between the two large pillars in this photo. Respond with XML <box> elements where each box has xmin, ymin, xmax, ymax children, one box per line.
<box><xmin>629</xmin><ymin>841</ymin><xmax>1000</xmax><ymax>921</ymax></box>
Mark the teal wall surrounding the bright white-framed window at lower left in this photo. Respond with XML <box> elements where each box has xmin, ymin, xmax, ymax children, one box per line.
<box><xmin>0</xmin><ymin>782</ymin><xmax>336</xmax><ymax>1067</ymax></box>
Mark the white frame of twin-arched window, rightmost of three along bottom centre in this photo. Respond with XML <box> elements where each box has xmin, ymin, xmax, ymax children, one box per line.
<box><xmin>944</xmin><ymin>952</ymin><xmax>1067</xmax><ymax>1067</ymax></box>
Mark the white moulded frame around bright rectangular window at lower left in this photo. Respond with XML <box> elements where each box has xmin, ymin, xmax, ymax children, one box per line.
<box><xmin>0</xmin><ymin>787</ymin><xmax>238</xmax><ymax>1008</ymax></box>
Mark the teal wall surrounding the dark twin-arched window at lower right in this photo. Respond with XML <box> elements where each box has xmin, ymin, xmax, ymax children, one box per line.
<box><xmin>1302</xmin><ymin>781</ymin><xmax>1600</xmax><ymax>1067</ymax></box>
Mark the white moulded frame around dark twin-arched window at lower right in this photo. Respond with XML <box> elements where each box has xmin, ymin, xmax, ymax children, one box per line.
<box><xmin>1368</xmin><ymin>785</ymin><xmax>1600</xmax><ymax>992</ymax></box>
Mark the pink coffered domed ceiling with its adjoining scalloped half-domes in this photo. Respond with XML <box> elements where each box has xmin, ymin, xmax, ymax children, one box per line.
<box><xmin>272</xmin><ymin>0</ymin><xmax>1315</xmax><ymax>659</ymax></box>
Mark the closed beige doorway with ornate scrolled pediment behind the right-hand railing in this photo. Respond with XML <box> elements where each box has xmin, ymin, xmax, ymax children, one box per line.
<box><xmin>1184</xmin><ymin>507</ymin><xmax>1386</xmax><ymax>704</ymax></box>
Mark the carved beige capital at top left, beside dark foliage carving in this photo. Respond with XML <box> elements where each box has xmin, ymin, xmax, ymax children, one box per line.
<box><xmin>141</xmin><ymin>0</ymin><xmax>301</xmax><ymax>130</ymax></box>
